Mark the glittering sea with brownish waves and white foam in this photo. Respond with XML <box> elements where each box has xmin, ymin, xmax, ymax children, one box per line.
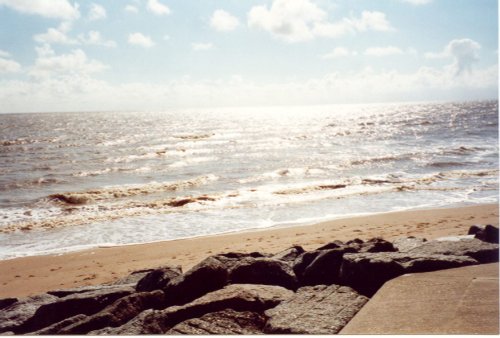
<box><xmin>0</xmin><ymin>101</ymin><xmax>499</xmax><ymax>259</ymax></box>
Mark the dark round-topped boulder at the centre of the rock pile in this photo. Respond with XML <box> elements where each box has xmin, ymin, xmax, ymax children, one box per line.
<box><xmin>229</xmin><ymin>258</ymin><xmax>297</xmax><ymax>290</ymax></box>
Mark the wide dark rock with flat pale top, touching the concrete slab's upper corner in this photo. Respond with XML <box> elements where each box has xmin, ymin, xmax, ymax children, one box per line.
<box><xmin>340</xmin><ymin>252</ymin><xmax>478</xmax><ymax>297</ymax></box>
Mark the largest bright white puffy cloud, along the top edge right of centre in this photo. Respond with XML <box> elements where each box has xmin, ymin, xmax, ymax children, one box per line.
<box><xmin>248</xmin><ymin>0</ymin><xmax>393</xmax><ymax>42</ymax></box>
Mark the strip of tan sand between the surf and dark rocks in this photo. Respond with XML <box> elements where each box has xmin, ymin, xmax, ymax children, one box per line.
<box><xmin>0</xmin><ymin>204</ymin><xmax>498</xmax><ymax>298</ymax></box>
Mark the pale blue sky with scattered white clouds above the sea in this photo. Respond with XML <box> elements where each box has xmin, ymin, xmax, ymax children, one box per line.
<box><xmin>0</xmin><ymin>0</ymin><xmax>499</xmax><ymax>113</ymax></box>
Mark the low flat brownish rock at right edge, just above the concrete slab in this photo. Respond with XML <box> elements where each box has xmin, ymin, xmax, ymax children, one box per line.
<box><xmin>408</xmin><ymin>238</ymin><xmax>498</xmax><ymax>263</ymax></box>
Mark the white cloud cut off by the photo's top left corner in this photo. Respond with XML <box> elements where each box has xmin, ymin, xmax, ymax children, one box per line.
<box><xmin>0</xmin><ymin>0</ymin><xmax>80</xmax><ymax>20</ymax></box>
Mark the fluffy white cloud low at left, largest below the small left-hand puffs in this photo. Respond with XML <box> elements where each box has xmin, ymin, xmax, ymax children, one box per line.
<box><xmin>29</xmin><ymin>45</ymin><xmax>107</xmax><ymax>79</ymax></box>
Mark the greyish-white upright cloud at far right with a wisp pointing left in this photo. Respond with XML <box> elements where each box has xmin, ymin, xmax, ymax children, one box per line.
<box><xmin>425</xmin><ymin>38</ymin><xmax>481</xmax><ymax>75</ymax></box>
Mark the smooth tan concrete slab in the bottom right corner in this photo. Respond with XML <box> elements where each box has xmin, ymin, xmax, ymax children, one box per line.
<box><xmin>340</xmin><ymin>263</ymin><xmax>500</xmax><ymax>334</ymax></box>
